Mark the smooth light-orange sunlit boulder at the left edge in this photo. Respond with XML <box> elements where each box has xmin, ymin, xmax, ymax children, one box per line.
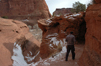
<box><xmin>0</xmin><ymin>18</ymin><xmax>40</xmax><ymax>66</ymax></box>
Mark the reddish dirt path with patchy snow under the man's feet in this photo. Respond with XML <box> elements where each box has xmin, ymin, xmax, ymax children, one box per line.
<box><xmin>36</xmin><ymin>44</ymin><xmax>84</xmax><ymax>66</ymax></box>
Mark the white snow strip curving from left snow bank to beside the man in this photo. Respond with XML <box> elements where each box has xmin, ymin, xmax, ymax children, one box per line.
<box><xmin>12</xmin><ymin>40</ymin><xmax>66</xmax><ymax>66</ymax></box>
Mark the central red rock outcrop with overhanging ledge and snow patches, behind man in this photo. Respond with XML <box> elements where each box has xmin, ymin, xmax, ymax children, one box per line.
<box><xmin>38</xmin><ymin>12</ymin><xmax>86</xmax><ymax>58</ymax></box>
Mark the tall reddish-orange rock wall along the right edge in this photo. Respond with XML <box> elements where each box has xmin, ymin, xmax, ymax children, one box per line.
<box><xmin>79</xmin><ymin>0</ymin><xmax>101</xmax><ymax>66</ymax></box>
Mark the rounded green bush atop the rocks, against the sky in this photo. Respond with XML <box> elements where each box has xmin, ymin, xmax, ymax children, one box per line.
<box><xmin>72</xmin><ymin>1</ymin><xmax>86</xmax><ymax>13</ymax></box>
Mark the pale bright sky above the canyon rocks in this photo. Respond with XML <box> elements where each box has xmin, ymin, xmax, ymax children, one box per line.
<box><xmin>45</xmin><ymin>0</ymin><xmax>91</xmax><ymax>14</ymax></box>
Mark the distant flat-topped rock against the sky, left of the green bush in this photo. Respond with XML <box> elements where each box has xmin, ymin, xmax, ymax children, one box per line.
<box><xmin>53</xmin><ymin>8</ymin><xmax>72</xmax><ymax>16</ymax></box>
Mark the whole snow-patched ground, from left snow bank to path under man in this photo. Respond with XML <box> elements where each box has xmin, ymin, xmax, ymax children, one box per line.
<box><xmin>11</xmin><ymin>40</ymin><xmax>84</xmax><ymax>66</ymax></box>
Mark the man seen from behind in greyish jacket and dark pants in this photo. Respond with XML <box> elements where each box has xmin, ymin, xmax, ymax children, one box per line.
<box><xmin>65</xmin><ymin>32</ymin><xmax>75</xmax><ymax>61</ymax></box>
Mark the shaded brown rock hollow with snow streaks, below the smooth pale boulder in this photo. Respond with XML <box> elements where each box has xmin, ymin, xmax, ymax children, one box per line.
<box><xmin>13</xmin><ymin>36</ymin><xmax>40</xmax><ymax>64</ymax></box>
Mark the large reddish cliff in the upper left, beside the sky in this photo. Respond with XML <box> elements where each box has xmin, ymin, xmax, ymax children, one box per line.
<box><xmin>0</xmin><ymin>0</ymin><xmax>51</xmax><ymax>22</ymax></box>
